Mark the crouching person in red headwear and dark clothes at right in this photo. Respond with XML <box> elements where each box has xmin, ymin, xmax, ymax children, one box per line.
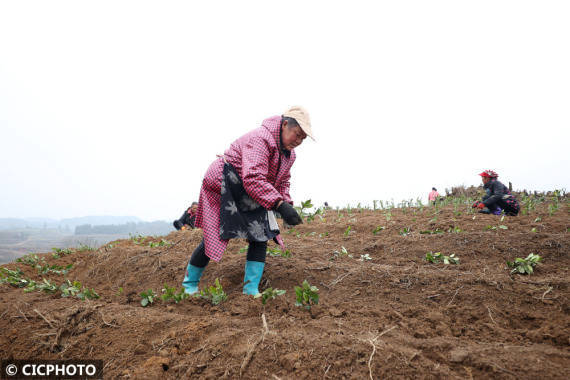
<box><xmin>473</xmin><ymin>170</ymin><xmax>520</xmax><ymax>215</ymax></box>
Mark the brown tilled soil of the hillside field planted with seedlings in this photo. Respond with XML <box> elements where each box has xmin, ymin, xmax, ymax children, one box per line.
<box><xmin>0</xmin><ymin>200</ymin><xmax>570</xmax><ymax>379</ymax></box>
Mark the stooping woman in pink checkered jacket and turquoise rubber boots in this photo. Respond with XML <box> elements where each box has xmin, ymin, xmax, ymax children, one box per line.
<box><xmin>182</xmin><ymin>107</ymin><xmax>314</xmax><ymax>295</ymax></box>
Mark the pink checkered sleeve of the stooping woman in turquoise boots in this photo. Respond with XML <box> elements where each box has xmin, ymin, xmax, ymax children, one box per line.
<box><xmin>241</xmin><ymin>136</ymin><xmax>283</xmax><ymax>210</ymax></box>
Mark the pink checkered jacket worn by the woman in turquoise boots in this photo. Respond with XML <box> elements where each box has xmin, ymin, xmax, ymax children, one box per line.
<box><xmin>196</xmin><ymin>116</ymin><xmax>295</xmax><ymax>261</ymax></box>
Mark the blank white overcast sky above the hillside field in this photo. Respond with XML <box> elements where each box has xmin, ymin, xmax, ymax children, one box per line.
<box><xmin>0</xmin><ymin>0</ymin><xmax>570</xmax><ymax>220</ymax></box>
